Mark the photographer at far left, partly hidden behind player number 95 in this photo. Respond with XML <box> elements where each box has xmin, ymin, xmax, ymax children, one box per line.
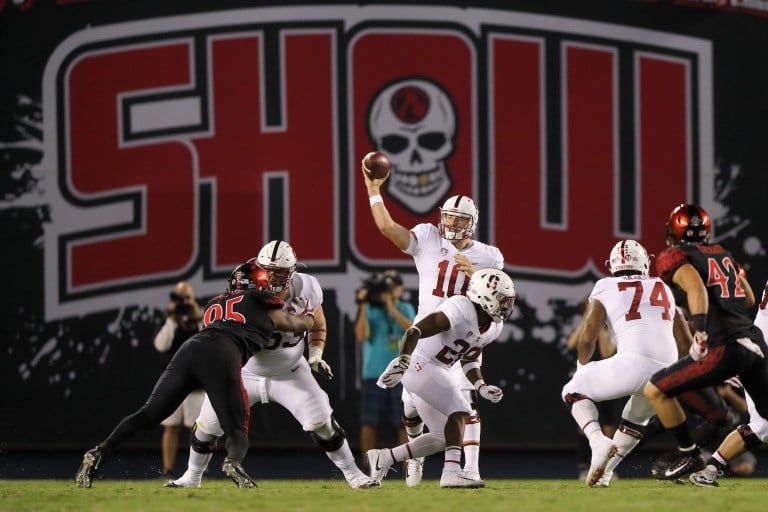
<box><xmin>155</xmin><ymin>281</ymin><xmax>205</xmax><ymax>477</ymax></box>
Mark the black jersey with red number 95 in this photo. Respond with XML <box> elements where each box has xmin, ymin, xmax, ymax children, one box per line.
<box><xmin>199</xmin><ymin>289</ymin><xmax>283</xmax><ymax>364</ymax></box>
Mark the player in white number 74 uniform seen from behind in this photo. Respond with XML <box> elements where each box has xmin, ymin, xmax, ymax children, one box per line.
<box><xmin>562</xmin><ymin>240</ymin><xmax>690</xmax><ymax>487</ymax></box>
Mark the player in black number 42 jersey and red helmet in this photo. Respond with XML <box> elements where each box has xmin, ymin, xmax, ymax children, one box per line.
<box><xmin>645</xmin><ymin>204</ymin><xmax>768</xmax><ymax>480</ymax></box>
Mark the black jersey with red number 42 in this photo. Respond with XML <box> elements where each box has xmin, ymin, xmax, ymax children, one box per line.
<box><xmin>656</xmin><ymin>244</ymin><xmax>753</xmax><ymax>346</ymax></box>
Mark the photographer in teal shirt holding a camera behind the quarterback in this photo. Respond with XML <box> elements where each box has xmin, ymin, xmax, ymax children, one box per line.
<box><xmin>355</xmin><ymin>270</ymin><xmax>416</xmax><ymax>474</ymax></box>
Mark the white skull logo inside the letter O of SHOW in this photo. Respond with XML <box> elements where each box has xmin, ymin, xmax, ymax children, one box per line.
<box><xmin>368</xmin><ymin>78</ymin><xmax>456</xmax><ymax>215</ymax></box>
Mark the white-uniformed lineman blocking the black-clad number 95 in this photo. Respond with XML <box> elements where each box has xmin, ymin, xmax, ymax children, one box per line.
<box><xmin>165</xmin><ymin>240</ymin><xmax>380</xmax><ymax>489</ymax></box>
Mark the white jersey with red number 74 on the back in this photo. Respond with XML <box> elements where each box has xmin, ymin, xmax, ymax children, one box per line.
<box><xmin>589</xmin><ymin>276</ymin><xmax>678</xmax><ymax>363</ymax></box>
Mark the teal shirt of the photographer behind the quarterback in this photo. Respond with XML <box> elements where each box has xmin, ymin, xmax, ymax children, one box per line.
<box><xmin>363</xmin><ymin>301</ymin><xmax>416</xmax><ymax>379</ymax></box>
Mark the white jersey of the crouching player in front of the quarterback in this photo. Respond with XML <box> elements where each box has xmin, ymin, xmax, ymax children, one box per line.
<box><xmin>411</xmin><ymin>295</ymin><xmax>503</xmax><ymax>369</ymax></box>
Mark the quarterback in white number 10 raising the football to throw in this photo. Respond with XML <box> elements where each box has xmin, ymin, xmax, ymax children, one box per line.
<box><xmin>362</xmin><ymin>158</ymin><xmax>504</xmax><ymax>486</ymax></box>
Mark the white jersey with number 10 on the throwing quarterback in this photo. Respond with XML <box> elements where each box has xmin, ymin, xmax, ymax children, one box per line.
<box><xmin>403</xmin><ymin>224</ymin><xmax>504</xmax><ymax>323</ymax></box>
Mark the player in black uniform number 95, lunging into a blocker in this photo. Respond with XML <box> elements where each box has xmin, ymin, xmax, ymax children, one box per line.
<box><xmin>75</xmin><ymin>259</ymin><xmax>315</xmax><ymax>488</ymax></box>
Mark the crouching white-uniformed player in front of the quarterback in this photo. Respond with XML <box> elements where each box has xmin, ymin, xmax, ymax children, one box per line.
<box><xmin>366</xmin><ymin>268</ymin><xmax>515</xmax><ymax>488</ymax></box>
